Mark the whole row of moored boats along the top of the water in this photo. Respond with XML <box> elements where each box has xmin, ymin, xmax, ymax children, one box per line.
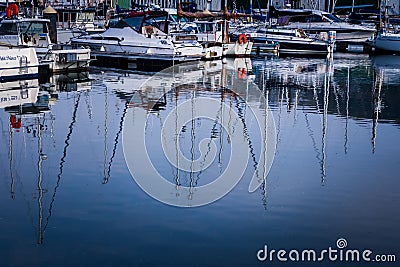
<box><xmin>0</xmin><ymin>4</ymin><xmax>400</xmax><ymax>81</ymax></box>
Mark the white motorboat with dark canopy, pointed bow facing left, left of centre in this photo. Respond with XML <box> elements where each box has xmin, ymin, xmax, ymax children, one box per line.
<box><xmin>71</xmin><ymin>11</ymin><xmax>204</xmax><ymax>69</ymax></box>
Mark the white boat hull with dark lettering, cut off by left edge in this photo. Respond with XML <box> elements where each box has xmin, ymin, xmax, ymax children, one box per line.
<box><xmin>0</xmin><ymin>46</ymin><xmax>39</xmax><ymax>82</ymax></box>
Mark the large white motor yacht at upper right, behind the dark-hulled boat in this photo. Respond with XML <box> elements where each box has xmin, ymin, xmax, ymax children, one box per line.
<box><xmin>276</xmin><ymin>9</ymin><xmax>376</xmax><ymax>42</ymax></box>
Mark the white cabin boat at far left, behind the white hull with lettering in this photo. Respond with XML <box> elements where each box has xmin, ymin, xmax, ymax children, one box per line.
<box><xmin>0</xmin><ymin>17</ymin><xmax>90</xmax><ymax>73</ymax></box>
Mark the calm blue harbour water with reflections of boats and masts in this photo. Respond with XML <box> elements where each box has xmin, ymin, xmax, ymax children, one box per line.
<box><xmin>0</xmin><ymin>54</ymin><xmax>400</xmax><ymax>266</ymax></box>
